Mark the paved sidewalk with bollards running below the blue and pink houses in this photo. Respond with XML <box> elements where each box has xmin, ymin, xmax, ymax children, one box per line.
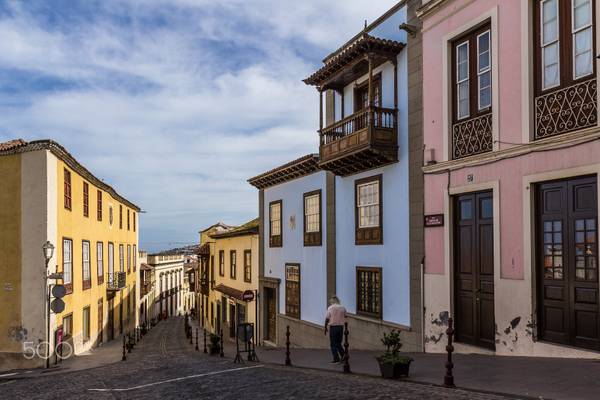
<box><xmin>194</xmin><ymin>321</ymin><xmax>600</xmax><ymax>399</ymax></box>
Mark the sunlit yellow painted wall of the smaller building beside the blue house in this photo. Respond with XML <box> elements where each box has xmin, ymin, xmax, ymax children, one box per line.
<box><xmin>208</xmin><ymin>235</ymin><xmax>258</xmax><ymax>337</ymax></box>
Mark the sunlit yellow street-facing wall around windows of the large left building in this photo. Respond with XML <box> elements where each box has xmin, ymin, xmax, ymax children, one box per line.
<box><xmin>53</xmin><ymin>160</ymin><xmax>139</xmax><ymax>353</ymax></box>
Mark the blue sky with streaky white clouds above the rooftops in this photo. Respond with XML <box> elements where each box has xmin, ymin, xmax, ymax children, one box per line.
<box><xmin>0</xmin><ymin>0</ymin><xmax>397</xmax><ymax>251</ymax></box>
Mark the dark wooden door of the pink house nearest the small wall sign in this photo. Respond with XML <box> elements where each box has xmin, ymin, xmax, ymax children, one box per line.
<box><xmin>454</xmin><ymin>192</ymin><xmax>496</xmax><ymax>349</ymax></box>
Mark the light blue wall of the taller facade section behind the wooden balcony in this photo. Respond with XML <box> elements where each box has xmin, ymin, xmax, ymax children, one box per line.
<box><xmin>335</xmin><ymin>3</ymin><xmax>410</xmax><ymax>326</ymax></box>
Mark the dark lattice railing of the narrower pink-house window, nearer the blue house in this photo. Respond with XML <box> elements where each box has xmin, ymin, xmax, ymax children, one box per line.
<box><xmin>452</xmin><ymin>113</ymin><xmax>494</xmax><ymax>160</ymax></box>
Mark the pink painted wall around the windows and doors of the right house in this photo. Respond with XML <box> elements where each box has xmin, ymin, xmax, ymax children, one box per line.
<box><xmin>423</xmin><ymin>0</ymin><xmax>600</xmax><ymax>279</ymax></box>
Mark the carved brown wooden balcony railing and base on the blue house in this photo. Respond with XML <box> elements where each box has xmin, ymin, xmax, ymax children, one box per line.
<box><xmin>319</xmin><ymin>107</ymin><xmax>398</xmax><ymax>176</ymax></box>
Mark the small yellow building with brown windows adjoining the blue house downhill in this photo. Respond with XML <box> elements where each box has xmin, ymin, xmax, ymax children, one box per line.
<box><xmin>200</xmin><ymin>219</ymin><xmax>258</xmax><ymax>338</ymax></box>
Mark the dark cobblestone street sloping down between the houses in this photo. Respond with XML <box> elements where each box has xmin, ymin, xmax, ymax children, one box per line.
<box><xmin>0</xmin><ymin>318</ymin><xmax>508</xmax><ymax>400</ymax></box>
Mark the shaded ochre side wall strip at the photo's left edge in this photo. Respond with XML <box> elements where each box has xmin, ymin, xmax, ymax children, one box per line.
<box><xmin>0</xmin><ymin>154</ymin><xmax>24</xmax><ymax>352</ymax></box>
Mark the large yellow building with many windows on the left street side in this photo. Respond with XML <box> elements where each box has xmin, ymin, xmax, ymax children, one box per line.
<box><xmin>0</xmin><ymin>139</ymin><xmax>140</xmax><ymax>370</ymax></box>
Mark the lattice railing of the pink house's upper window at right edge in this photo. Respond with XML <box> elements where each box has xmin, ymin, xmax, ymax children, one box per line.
<box><xmin>535</xmin><ymin>78</ymin><xmax>598</xmax><ymax>139</ymax></box>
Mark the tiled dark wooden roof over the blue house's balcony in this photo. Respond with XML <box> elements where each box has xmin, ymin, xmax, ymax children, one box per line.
<box><xmin>304</xmin><ymin>32</ymin><xmax>405</xmax><ymax>90</ymax></box>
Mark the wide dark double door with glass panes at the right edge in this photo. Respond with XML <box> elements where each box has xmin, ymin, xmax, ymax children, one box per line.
<box><xmin>536</xmin><ymin>177</ymin><xmax>600</xmax><ymax>349</ymax></box>
